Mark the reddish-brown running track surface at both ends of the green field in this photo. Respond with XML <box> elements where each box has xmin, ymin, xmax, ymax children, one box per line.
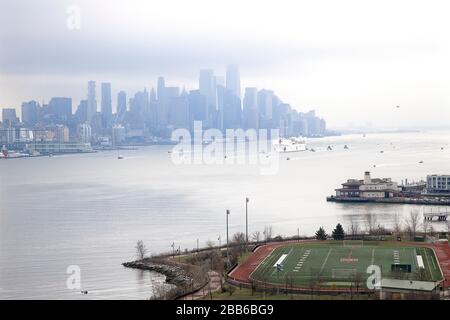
<box><xmin>229</xmin><ymin>241</ymin><xmax>450</xmax><ymax>288</ymax></box>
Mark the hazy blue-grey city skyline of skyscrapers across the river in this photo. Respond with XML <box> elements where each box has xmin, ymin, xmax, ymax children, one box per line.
<box><xmin>0</xmin><ymin>64</ymin><xmax>326</xmax><ymax>151</ymax></box>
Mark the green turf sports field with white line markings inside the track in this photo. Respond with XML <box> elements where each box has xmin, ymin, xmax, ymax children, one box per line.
<box><xmin>251</xmin><ymin>242</ymin><xmax>442</xmax><ymax>287</ymax></box>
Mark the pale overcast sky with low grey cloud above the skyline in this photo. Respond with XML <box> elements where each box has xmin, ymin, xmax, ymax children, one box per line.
<box><xmin>0</xmin><ymin>0</ymin><xmax>450</xmax><ymax>128</ymax></box>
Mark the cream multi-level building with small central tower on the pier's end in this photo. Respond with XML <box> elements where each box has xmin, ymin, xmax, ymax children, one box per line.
<box><xmin>335</xmin><ymin>171</ymin><xmax>401</xmax><ymax>198</ymax></box>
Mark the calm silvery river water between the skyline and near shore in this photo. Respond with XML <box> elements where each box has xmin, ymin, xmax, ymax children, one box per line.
<box><xmin>0</xmin><ymin>132</ymin><xmax>450</xmax><ymax>299</ymax></box>
